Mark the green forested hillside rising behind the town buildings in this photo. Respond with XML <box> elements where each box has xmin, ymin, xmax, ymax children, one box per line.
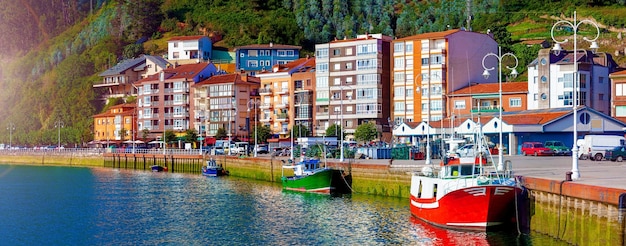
<box><xmin>0</xmin><ymin>0</ymin><xmax>626</xmax><ymax>145</ymax></box>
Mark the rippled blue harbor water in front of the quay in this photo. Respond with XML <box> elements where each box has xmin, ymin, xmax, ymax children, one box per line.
<box><xmin>0</xmin><ymin>165</ymin><xmax>567</xmax><ymax>245</ymax></box>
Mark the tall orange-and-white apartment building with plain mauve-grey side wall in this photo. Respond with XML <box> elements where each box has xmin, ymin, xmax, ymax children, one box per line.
<box><xmin>391</xmin><ymin>29</ymin><xmax>498</xmax><ymax>122</ymax></box>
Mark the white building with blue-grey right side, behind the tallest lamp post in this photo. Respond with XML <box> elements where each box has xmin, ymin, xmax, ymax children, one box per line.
<box><xmin>527</xmin><ymin>49</ymin><xmax>617</xmax><ymax>115</ymax></box>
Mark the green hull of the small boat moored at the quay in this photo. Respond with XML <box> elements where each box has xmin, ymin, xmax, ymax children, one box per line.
<box><xmin>282</xmin><ymin>169</ymin><xmax>334</xmax><ymax>194</ymax></box>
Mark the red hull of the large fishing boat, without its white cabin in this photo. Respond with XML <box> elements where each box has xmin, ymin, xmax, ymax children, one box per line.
<box><xmin>410</xmin><ymin>185</ymin><xmax>521</xmax><ymax>231</ymax></box>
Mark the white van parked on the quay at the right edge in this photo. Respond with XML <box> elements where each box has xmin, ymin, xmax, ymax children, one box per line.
<box><xmin>578</xmin><ymin>135</ymin><xmax>624</xmax><ymax>161</ymax></box>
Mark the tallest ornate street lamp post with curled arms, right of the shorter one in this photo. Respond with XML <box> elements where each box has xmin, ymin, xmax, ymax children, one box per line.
<box><xmin>550</xmin><ymin>11</ymin><xmax>600</xmax><ymax>179</ymax></box>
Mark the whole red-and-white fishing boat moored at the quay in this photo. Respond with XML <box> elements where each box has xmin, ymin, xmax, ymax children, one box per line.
<box><xmin>410</xmin><ymin>128</ymin><xmax>521</xmax><ymax>231</ymax></box>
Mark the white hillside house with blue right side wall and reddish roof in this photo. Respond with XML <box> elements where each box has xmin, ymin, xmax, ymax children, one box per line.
<box><xmin>167</xmin><ymin>35</ymin><xmax>213</xmax><ymax>64</ymax></box>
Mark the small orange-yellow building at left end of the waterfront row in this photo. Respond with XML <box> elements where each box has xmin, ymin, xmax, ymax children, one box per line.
<box><xmin>93</xmin><ymin>103</ymin><xmax>136</xmax><ymax>146</ymax></box>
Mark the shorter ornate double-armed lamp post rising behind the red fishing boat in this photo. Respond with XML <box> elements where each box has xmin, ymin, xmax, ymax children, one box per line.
<box><xmin>483</xmin><ymin>47</ymin><xmax>519</xmax><ymax>171</ymax></box>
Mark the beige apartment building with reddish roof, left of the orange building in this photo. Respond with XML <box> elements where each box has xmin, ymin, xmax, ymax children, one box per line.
<box><xmin>191</xmin><ymin>73</ymin><xmax>260</xmax><ymax>142</ymax></box>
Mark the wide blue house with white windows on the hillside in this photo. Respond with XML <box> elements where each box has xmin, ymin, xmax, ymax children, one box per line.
<box><xmin>235</xmin><ymin>43</ymin><xmax>302</xmax><ymax>75</ymax></box>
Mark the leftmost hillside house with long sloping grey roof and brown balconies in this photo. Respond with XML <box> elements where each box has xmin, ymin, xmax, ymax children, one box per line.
<box><xmin>93</xmin><ymin>55</ymin><xmax>171</xmax><ymax>100</ymax></box>
